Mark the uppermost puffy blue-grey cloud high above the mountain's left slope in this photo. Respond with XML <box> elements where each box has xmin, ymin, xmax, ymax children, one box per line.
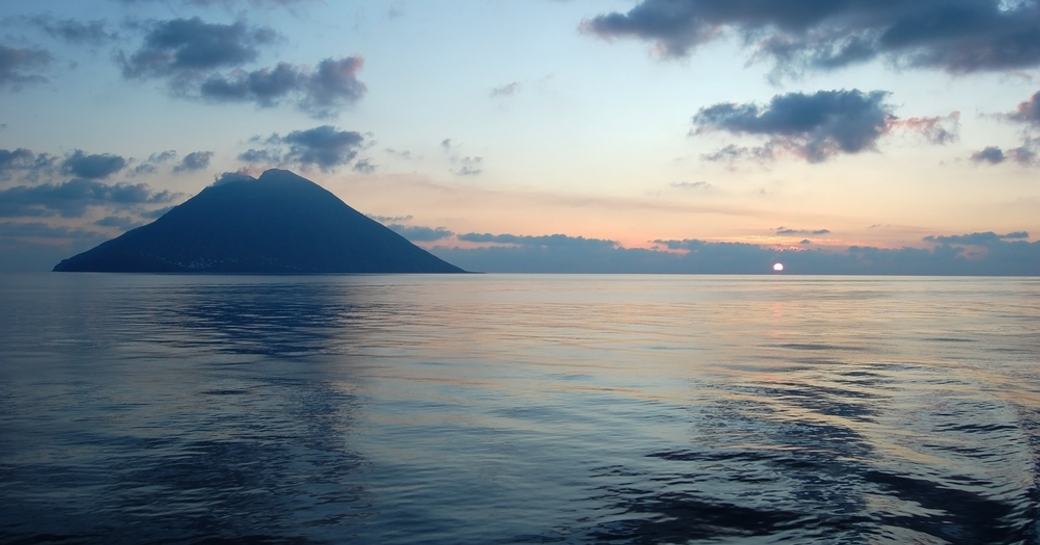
<box><xmin>119</xmin><ymin>17</ymin><xmax>278</xmax><ymax>81</ymax></box>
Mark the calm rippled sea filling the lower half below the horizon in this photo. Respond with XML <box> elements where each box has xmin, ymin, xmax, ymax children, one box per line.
<box><xmin>0</xmin><ymin>274</ymin><xmax>1040</xmax><ymax>544</ymax></box>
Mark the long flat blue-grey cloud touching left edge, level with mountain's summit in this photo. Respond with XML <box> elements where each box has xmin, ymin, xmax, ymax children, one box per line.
<box><xmin>0</xmin><ymin>178</ymin><xmax>177</xmax><ymax>217</ymax></box>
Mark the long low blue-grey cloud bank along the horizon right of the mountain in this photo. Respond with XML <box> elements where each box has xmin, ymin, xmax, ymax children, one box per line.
<box><xmin>432</xmin><ymin>229</ymin><xmax>1040</xmax><ymax>275</ymax></box>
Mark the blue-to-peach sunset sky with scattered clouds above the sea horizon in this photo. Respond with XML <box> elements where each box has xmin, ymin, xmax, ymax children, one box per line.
<box><xmin>0</xmin><ymin>0</ymin><xmax>1040</xmax><ymax>275</ymax></box>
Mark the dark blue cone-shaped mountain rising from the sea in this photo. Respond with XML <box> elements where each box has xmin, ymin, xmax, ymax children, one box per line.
<box><xmin>54</xmin><ymin>170</ymin><xmax>463</xmax><ymax>274</ymax></box>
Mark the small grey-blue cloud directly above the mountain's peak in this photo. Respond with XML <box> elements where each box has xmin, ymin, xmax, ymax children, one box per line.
<box><xmin>245</xmin><ymin>125</ymin><xmax>367</xmax><ymax>172</ymax></box>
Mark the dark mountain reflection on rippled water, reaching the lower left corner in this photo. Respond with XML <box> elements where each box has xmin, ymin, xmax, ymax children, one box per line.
<box><xmin>0</xmin><ymin>283</ymin><xmax>370</xmax><ymax>543</ymax></box>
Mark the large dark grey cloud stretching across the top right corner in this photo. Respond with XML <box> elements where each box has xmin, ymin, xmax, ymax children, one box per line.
<box><xmin>581</xmin><ymin>0</ymin><xmax>1040</xmax><ymax>74</ymax></box>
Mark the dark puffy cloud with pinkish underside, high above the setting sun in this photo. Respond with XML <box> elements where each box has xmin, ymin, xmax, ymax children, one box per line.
<box><xmin>693</xmin><ymin>89</ymin><xmax>892</xmax><ymax>162</ymax></box>
